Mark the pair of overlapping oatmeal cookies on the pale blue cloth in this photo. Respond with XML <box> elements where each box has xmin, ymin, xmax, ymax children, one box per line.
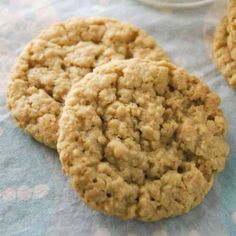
<box><xmin>8</xmin><ymin>18</ymin><xmax>229</xmax><ymax>221</ymax></box>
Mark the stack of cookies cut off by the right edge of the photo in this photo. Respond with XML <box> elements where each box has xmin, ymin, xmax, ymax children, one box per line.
<box><xmin>213</xmin><ymin>0</ymin><xmax>236</xmax><ymax>89</ymax></box>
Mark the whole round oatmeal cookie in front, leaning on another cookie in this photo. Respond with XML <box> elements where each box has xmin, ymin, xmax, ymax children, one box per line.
<box><xmin>58</xmin><ymin>59</ymin><xmax>229</xmax><ymax>221</ymax></box>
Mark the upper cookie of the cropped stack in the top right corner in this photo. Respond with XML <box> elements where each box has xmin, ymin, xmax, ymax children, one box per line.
<box><xmin>227</xmin><ymin>0</ymin><xmax>236</xmax><ymax>61</ymax></box>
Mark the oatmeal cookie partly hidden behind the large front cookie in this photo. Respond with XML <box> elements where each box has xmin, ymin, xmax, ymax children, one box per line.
<box><xmin>8</xmin><ymin>18</ymin><xmax>166</xmax><ymax>147</ymax></box>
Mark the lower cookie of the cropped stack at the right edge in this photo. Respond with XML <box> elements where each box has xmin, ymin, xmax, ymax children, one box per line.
<box><xmin>213</xmin><ymin>17</ymin><xmax>236</xmax><ymax>88</ymax></box>
